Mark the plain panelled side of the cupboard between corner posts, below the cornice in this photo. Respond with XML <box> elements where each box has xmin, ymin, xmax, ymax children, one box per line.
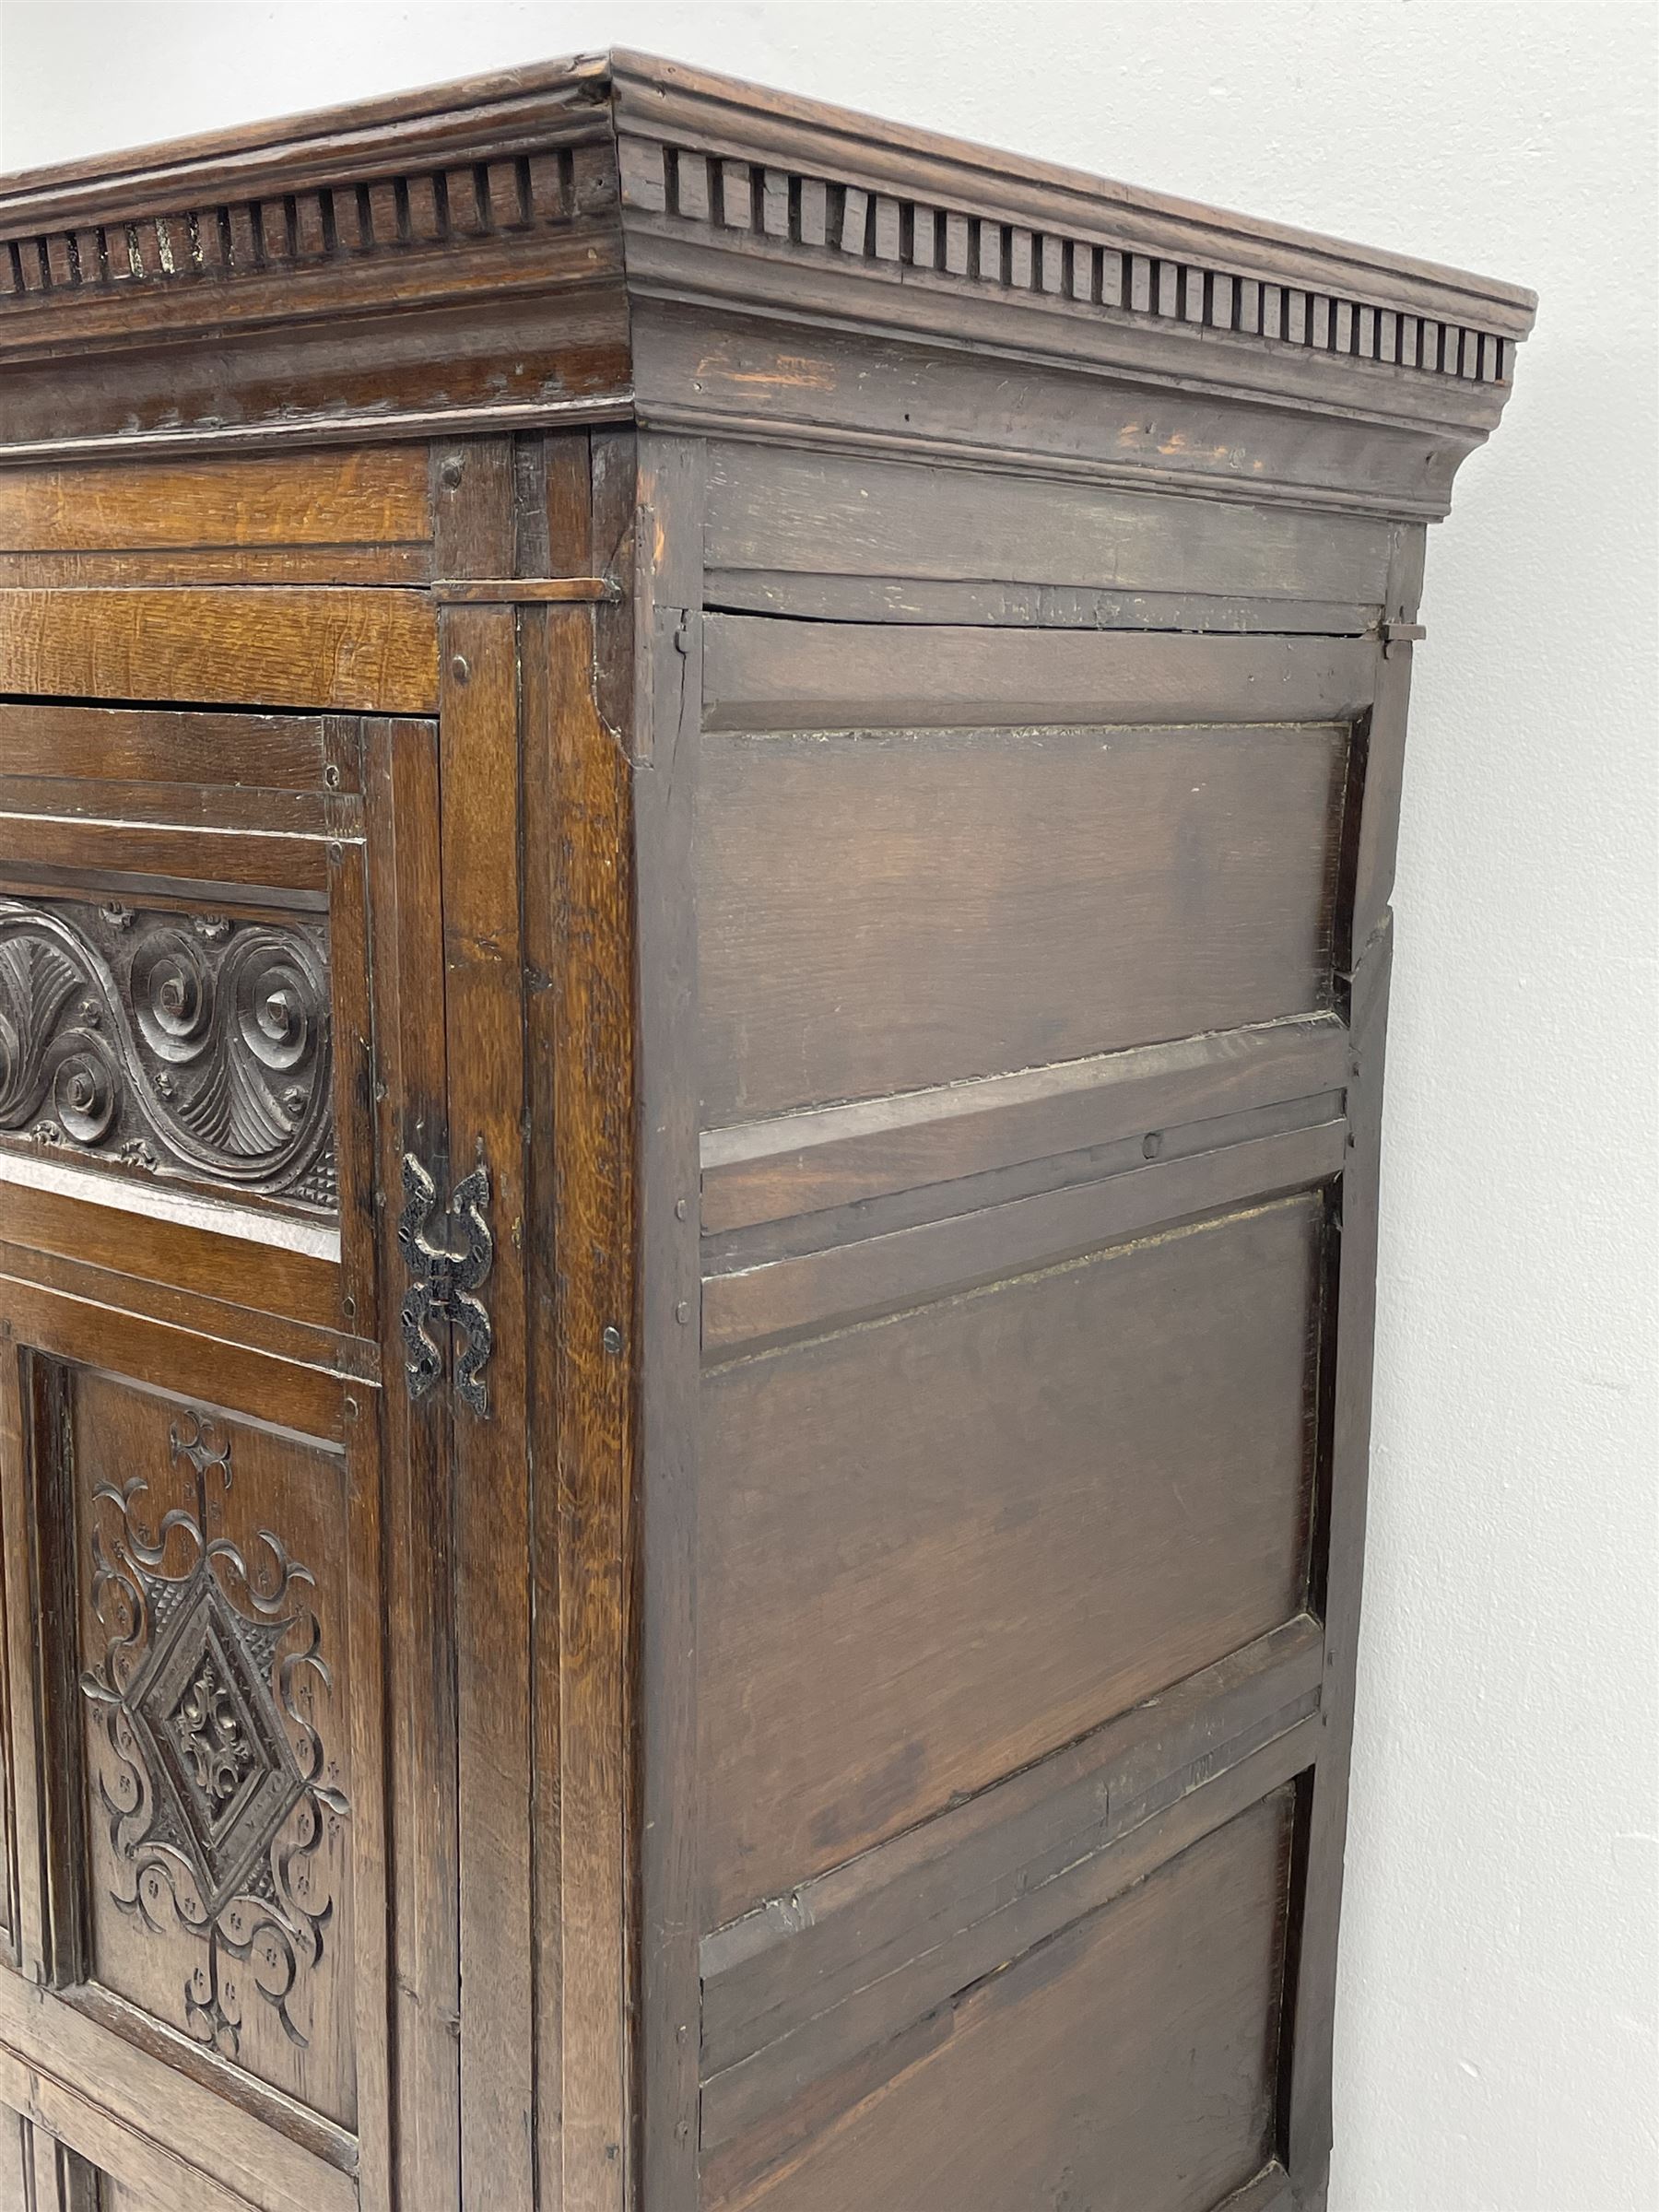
<box><xmin>686</xmin><ymin>447</ymin><xmax>1398</xmax><ymax>2212</ymax></box>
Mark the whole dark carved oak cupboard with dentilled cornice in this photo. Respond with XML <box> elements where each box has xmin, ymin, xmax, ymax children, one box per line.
<box><xmin>0</xmin><ymin>55</ymin><xmax>1533</xmax><ymax>2212</ymax></box>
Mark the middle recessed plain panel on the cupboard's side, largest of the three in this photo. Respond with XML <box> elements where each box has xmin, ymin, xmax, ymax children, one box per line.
<box><xmin>699</xmin><ymin>1194</ymin><xmax>1323</xmax><ymax>1929</ymax></box>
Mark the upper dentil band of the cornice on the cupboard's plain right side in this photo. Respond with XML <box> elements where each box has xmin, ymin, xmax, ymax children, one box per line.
<box><xmin>610</xmin><ymin>53</ymin><xmax>1537</xmax><ymax>431</ymax></box>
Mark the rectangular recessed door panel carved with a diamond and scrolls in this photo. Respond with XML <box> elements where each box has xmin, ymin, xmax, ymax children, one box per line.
<box><xmin>65</xmin><ymin>1373</ymin><xmax>356</xmax><ymax>2125</ymax></box>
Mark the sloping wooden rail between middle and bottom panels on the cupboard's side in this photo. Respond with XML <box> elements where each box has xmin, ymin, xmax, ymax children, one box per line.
<box><xmin>699</xmin><ymin>1613</ymin><xmax>1325</xmax><ymax>2088</ymax></box>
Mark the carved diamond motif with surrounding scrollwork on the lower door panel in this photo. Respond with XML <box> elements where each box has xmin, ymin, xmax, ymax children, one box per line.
<box><xmin>82</xmin><ymin>1414</ymin><xmax>347</xmax><ymax>2059</ymax></box>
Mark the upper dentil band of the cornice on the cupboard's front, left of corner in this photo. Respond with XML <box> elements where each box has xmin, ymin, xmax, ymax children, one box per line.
<box><xmin>0</xmin><ymin>65</ymin><xmax>618</xmax><ymax>360</ymax></box>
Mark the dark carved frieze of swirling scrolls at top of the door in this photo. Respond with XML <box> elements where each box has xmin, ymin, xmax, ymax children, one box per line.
<box><xmin>0</xmin><ymin>898</ymin><xmax>334</xmax><ymax>1206</ymax></box>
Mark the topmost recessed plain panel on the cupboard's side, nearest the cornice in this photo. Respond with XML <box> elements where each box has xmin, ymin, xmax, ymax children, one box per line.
<box><xmin>697</xmin><ymin>724</ymin><xmax>1347</xmax><ymax>1126</ymax></box>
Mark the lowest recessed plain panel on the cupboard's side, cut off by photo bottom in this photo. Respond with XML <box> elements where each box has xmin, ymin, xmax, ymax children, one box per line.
<box><xmin>703</xmin><ymin>1787</ymin><xmax>1294</xmax><ymax>2212</ymax></box>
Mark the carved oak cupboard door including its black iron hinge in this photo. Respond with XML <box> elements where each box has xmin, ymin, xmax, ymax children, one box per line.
<box><xmin>0</xmin><ymin>706</ymin><xmax>462</xmax><ymax>2212</ymax></box>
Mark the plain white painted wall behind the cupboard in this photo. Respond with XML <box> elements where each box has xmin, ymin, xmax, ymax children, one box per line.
<box><xmin>0</xmin><ymin>0</ymin><xmax>1659</xmax><ymax>2212</ymax></box>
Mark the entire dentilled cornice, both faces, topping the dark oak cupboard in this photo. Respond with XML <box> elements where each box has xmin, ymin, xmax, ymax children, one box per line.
<box><xmin>0</xmin><ymin>53</ymin><xmax>1535</xmax><ymax>518</ymax></box>
